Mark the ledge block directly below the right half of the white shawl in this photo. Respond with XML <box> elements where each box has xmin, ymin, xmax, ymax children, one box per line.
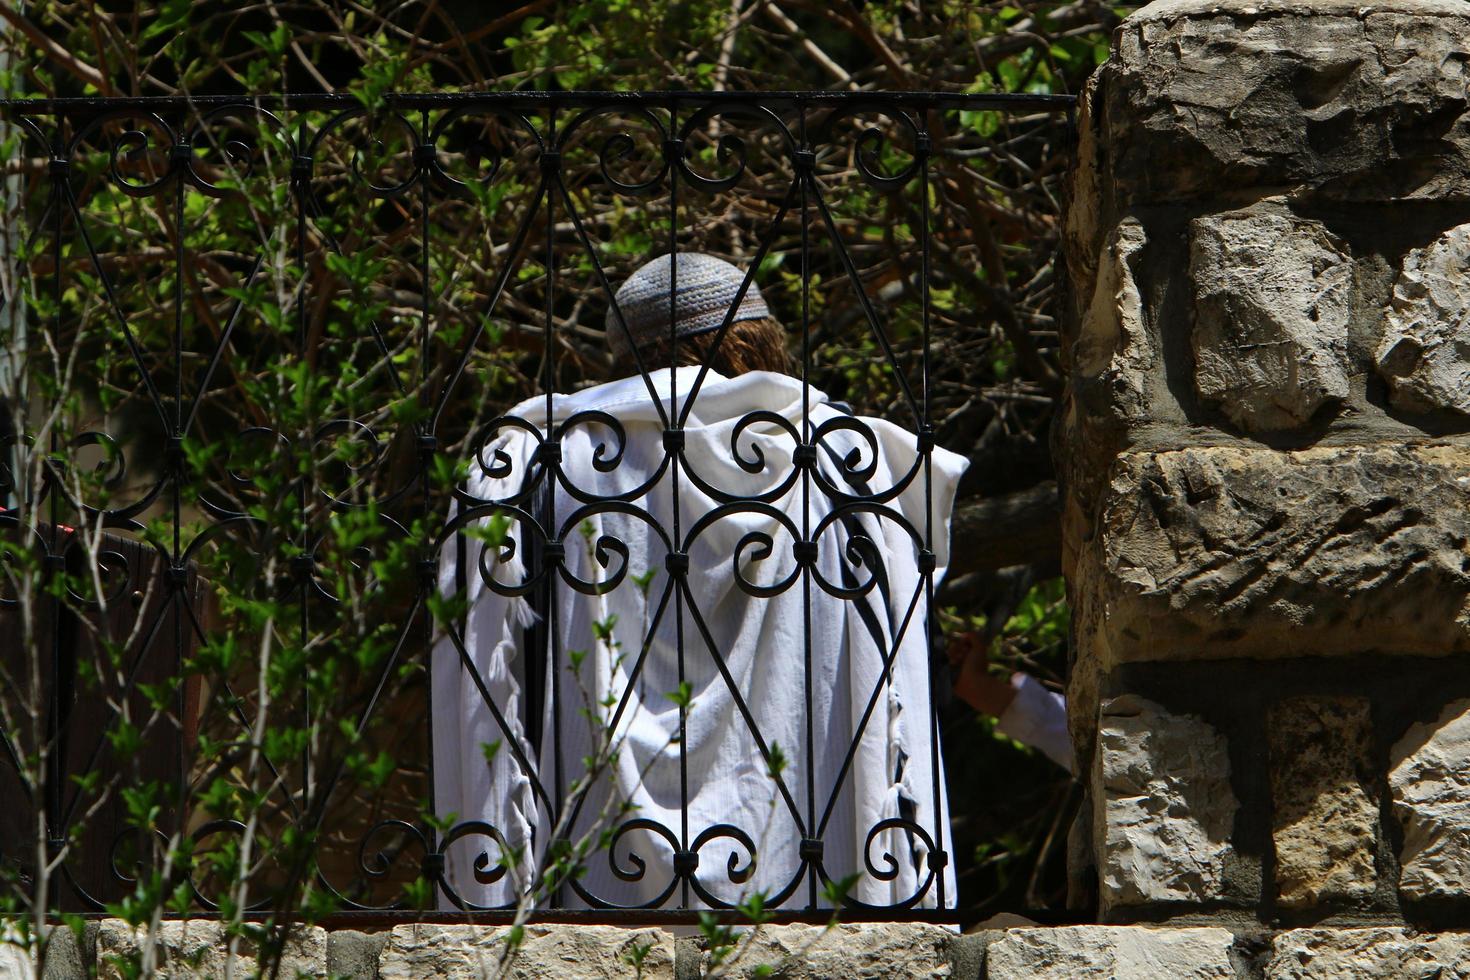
<box><xmin>701</xmin><ymin>923</ymin><xmax>956</xmax><ymax>980</ymax></box>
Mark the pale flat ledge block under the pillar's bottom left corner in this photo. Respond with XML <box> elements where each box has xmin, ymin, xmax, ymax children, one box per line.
<box><xmin>986</xmin><ymin>926</ymin><xmax>1235</xmax><ymax>980</ymax></box>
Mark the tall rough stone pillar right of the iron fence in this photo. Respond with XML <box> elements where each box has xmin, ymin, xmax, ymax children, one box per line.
<box><xmin>1064</xmin><ymin>0</ymin><xmax>1470</xmax><ymax>952</ymax></box>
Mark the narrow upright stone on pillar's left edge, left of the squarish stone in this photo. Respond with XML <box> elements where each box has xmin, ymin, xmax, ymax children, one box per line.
<box><xmin>1073</xmin><ymin>219</ymin><xmax>1158</xmax><ymax>422</ymax></box>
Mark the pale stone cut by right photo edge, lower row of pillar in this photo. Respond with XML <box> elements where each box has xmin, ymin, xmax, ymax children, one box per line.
<box><xmin>1388</xmin><ymin>701</ymin><xmax>1470</xmax><ymax>901</ymax></box>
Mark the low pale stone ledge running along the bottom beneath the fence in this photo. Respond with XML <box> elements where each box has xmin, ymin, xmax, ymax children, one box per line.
<box><xmin>14</xmin><ymin>920</ymin><xmax>1470</xmax><ymax>980</ymax></box>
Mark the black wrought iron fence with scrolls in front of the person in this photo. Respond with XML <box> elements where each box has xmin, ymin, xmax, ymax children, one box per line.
<box><xmin>0</xmin><ymin>93</ymin><xmax>1069</xmax><ymax>915</ymax></box>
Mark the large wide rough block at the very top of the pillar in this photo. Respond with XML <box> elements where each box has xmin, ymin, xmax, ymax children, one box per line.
<box><xmin>1101</xmin><ymin>0</ymin><xmax>1470</xmax><ymax>203</ymax></box>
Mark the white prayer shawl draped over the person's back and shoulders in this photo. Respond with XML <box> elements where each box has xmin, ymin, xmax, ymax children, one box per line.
<box><xmin>432</xmin><ymin>367</ymin><xmax>966</xmax><ymax>907</ymax></box>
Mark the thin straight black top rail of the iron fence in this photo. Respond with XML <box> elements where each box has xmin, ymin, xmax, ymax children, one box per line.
<box><xmin>0</xmin><ymin>91</ymin><xmax>1076</xmax><ymax>116</ymax></box>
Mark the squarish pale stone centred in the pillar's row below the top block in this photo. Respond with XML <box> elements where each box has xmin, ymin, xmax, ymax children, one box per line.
<box><xmin>1189</xmin><ymin>204</ymin><xmax>1352</xmax><ymax>432</ymax></box>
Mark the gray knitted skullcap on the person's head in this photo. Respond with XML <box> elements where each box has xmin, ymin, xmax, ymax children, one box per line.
<box><xmin>607</xmin><ymin>251</ymin><xmax>770</xmax><ymax>359</ymax></box>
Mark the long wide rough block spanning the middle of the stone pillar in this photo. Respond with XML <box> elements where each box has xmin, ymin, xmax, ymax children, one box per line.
<box><xmin>1072</xmin><ymin>445</ymin><xmax>1470</xmax><ymax>673</ymax></box>
